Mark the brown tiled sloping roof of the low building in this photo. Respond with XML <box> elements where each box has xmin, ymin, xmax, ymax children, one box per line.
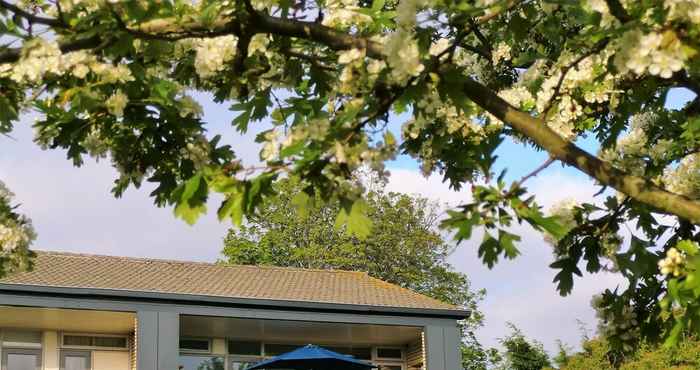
<box><xmin>0</xmin><ymin>252</ymin><xmax>457</xmax><ymax>310</ymax></box>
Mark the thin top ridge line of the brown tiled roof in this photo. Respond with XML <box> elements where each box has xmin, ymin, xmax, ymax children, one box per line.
<box><xmin>34</xmin><ymin>249</ymin><xmax>369</xmax><ymax>276</ymax></box>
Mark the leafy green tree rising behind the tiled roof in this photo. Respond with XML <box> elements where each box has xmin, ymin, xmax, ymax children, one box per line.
<box><xmin>223</xmin><ymin>179</ymin><xmax>492</xmax><ymax>369</ymax></box>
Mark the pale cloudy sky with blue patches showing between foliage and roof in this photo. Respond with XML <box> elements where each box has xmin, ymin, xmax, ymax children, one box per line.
<box><xmin>0</xmin><ymin>87</ymin><xmax>692</xmax><ymax>353</ymax></box>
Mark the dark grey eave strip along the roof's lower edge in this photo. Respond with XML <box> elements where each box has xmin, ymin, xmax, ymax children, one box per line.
<box><xmin>0</xmin><ymin>283</ymin><xmax>471</xmax><ymax>320</ymax></box>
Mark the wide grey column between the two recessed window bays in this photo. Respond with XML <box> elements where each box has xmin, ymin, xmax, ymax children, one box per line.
<box><xmin>136</xmin><ymin>311</ymin><xmax>180</xmax><ymax>370</ymax></box>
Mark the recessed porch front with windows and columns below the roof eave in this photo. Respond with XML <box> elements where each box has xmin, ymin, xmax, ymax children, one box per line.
<box><xmin>0</xmin><ymin>302</ymin><xmax>458</xmax><ymax>370</ymax></box>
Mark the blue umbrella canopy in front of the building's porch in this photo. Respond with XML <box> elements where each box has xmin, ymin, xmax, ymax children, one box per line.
<box><xmin>246</xmin><ymin>344</ymin><xmax>375</xmax><ymax>370</ymax></box>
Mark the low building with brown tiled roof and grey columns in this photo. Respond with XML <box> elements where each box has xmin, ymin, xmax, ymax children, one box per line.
<box><xmin>0</xmin><ymin>252</ymin><xmax>469</xmax><ymax>370</ymax></box>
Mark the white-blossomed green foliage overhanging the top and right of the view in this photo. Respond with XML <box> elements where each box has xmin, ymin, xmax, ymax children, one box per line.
<box><xmin>0</xmin><ymin>0</ymin><xmax>700</xmax><ymax>350</ymax></box>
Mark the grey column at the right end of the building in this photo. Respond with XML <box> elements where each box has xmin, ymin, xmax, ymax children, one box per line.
<box><xmin>423</xmin><ymin>325</ymin><xmax>462</xmax><ymax>370</ymax></box>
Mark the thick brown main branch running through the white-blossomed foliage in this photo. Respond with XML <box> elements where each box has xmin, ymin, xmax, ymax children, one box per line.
<box><xmin>0</xmin><ymin>7</ymin><xmax>700</xmax><ymax>224</ymax></box>
